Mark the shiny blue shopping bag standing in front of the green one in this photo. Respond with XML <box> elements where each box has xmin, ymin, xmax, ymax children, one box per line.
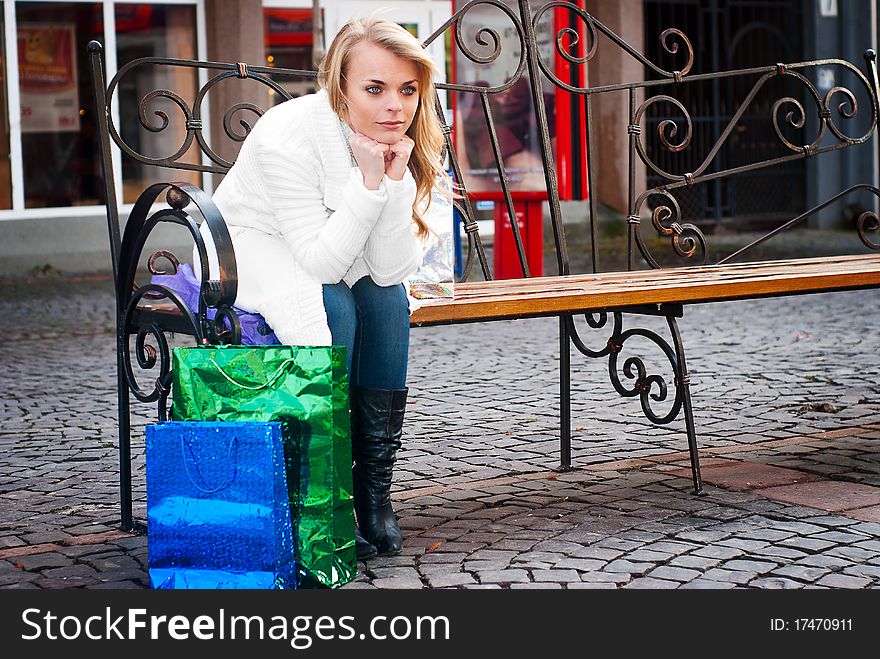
<box><xmin>146</xmin><ymin>421</ymin><xmax>296</xmax><ymax>589</ymax></box>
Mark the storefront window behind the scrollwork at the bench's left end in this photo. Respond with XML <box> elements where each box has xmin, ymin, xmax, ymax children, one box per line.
<box><xmin>115</xmin><ymin>3</ymin><xmax>199</xmax><ymax>203</ymax></box>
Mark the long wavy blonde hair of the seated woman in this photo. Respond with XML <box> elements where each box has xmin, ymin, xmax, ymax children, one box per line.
<box><xmin>318</xmin><ymin>17</ymin><xmax>448</xmax><ymax>237</ymax></box>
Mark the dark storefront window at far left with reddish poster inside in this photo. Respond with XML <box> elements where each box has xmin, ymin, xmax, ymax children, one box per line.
<box><xmin>16</xmin><ymin>2</ymin><xmax>104</xmax><ymax>208</ymax></box>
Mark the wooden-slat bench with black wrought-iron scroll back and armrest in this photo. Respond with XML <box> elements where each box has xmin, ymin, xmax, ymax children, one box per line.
<box><xmin>90</xmin><ymin>0</ymin><xmax>880</xmax><ymax>529</ymax></box>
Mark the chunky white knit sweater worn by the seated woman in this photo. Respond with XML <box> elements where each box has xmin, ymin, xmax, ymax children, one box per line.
<box><xmin>213</xmin><ymin>91</ymin><xmax>422</xmax><ymax>345</ymax></box>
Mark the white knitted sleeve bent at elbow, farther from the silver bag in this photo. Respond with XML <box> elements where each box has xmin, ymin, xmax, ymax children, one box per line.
<box><xmin>258</xmin><ymin>147</ymin><xmax>387</xmax><ymax>284</ymax></box>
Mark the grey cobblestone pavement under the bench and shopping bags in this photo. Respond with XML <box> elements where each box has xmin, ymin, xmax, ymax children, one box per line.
<box><xmin>0</xmin><ymin>277</ymin><xmax>880</xmax><ymax>589</ymax></box>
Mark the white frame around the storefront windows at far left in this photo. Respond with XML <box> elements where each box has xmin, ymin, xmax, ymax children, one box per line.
<box><xmin>0</xmin><ymin>0</ymin><xmax>205</xmax><ymax>221</ymax></box>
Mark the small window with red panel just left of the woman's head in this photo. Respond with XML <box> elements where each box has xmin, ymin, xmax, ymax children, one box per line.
<box><xmin>263</xmin><ymin>8</ymin><xmax>317</xmax><ymax>104</ymax></box>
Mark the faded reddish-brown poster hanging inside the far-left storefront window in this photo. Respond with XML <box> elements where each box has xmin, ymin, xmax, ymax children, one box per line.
<box><xmin>18</xmin><ymin>23</ymin><xmax>80</xmax><ymax>133</ymax></box>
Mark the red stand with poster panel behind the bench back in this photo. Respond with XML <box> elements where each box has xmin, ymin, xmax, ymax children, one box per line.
<box><xmin>450</xmin><ymin>0</ymin><xmax>587</xmax><ymax>279</ymax></box>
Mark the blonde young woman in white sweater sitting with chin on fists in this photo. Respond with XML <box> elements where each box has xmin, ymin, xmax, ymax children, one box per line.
<box><xmin>208</xmin><ymin>18</ymin><xmax>451</xmax><ymax>558</ymax></box>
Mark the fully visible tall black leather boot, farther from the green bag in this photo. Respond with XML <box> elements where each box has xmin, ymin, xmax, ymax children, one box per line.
<box><xmin>351</xmin><ymin>387</ymin><xmax>407</xmax><ymax>555</ymax></box>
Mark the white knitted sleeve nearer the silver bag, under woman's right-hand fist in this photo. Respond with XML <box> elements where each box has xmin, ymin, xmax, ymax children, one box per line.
<box><xmin>364</xmin><ymin>170</ymin><xmax>422</xmax><ymax>286</ymax></box>
